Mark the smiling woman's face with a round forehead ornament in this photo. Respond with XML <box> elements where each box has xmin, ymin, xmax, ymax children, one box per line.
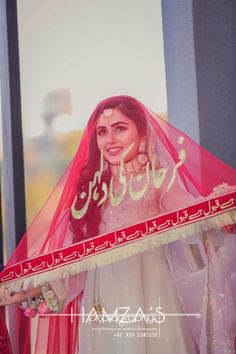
<box><xmin>96</xmin><ymin>109</ymin><xmax>141</xmax><ymax>165</ymax></box>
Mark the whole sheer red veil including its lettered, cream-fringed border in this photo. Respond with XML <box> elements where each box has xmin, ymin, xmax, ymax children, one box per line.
<box><xmin>1</xmin><ymin>96</ymin><xmax>236</xmax><ymax>354</ymax></box>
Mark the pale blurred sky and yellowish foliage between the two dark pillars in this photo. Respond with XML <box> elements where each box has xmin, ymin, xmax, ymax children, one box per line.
<box><xmin>17</xmin><ymin>0</ymin><xmax>167</xmax><ymax>224</ymax></box>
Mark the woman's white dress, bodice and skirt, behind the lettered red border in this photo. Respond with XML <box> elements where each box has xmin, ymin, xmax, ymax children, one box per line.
<box><xmin>79</xmin><ymin>183</ymin><xmax>197</xmax><ymax>354</ymax></box>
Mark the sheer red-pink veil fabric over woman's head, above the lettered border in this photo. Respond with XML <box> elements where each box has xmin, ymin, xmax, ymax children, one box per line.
<box><xmin>6</xmin><ymin>96</ymin><xmax>236</xmax><ymax>266</ymax></box>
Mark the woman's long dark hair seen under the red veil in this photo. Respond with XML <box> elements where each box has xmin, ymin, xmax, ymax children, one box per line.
<box><xmin>70</xmin><ymin>96</ymin><xmax>147</xmax><ymax>241</ymax></box>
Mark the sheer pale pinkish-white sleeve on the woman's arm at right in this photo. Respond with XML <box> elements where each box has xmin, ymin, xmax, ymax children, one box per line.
<box><xmin>159</xmin><ymin>174</ymin><xmax>236</xmax><ymax>354</ymax></box>
